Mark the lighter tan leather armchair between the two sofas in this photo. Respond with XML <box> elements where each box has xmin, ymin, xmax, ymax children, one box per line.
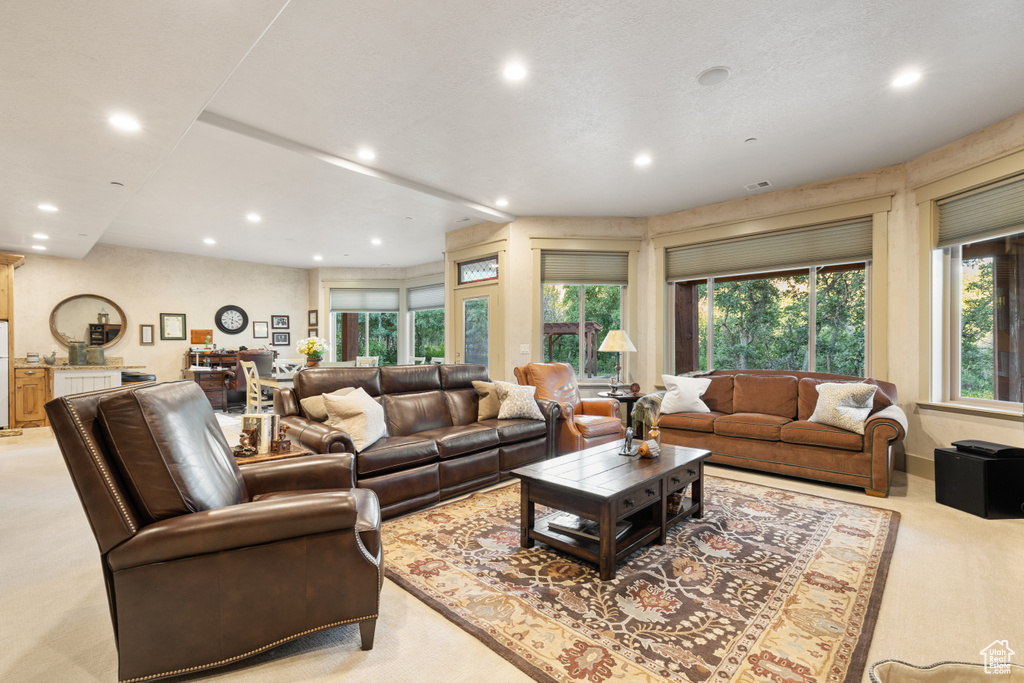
<box><xmin>515</xmin><ymin>362</ymin><xmax>626</xmax><ymax>455</ymax></box>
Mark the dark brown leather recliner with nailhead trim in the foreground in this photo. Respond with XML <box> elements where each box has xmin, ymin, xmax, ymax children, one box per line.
<box><xmin>46</xmin><ymin>382</ymin><xmax>383</xmax><ymax>681</ymax></box>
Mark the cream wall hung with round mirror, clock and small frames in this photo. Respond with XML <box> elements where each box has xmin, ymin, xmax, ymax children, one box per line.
<box><xmin>13</xmin><ymin>245</ymin><xmax>313</xmax><ymax>381</ymax></box>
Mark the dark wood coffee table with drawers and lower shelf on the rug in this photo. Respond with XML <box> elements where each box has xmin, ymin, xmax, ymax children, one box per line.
<box><xmin>512</xmin><ymin>441</ymin><xmax>711</xmax><ymax>581</ymax></box>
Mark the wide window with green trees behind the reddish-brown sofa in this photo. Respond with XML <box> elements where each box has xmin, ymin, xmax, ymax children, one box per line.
<box><xmin>675</xmin><ymin>263</ymin><xmax>866</xmax><ymax>377</ymax></box>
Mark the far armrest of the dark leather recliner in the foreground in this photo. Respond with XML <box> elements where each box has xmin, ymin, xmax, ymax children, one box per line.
<box><xmin>239</xmin><ymin>453</ymin><xmax>355</xmax><ymax>497</ymax></box>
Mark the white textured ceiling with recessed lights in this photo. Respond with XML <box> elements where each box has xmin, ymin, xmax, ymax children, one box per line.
<box><xmin>6</xmin><ymin>0</ymin><xmax>1024</xmax><ymax>267</ymax></box>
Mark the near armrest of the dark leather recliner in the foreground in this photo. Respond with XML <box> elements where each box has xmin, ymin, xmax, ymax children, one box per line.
<box><xmin>106</xmin><ymin>490</ymin><xmax>356</xmax><ymax>571</ymax></box>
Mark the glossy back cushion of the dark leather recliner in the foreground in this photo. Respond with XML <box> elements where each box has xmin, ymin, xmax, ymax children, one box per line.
<box><xmin>97</xmin><ymin>382</ymin><xmax>248</xmax><ymax>521</ymax></box>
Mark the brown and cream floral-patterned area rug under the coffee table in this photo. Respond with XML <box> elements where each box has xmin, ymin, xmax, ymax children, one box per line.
<box><xmin>383</xmin><ymin>477</ymin><xmax>899</xmax><ymax>683</ymax></box>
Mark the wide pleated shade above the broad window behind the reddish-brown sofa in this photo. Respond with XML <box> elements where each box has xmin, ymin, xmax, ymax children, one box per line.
<box><xmin>665</xmin><ymin>218</ymin><xmax>872</xmax><ymax>281</ymax></box>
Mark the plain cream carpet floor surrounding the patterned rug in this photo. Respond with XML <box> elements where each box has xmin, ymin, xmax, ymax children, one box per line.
<box><xmin>0</xmin><ymin>428</ymin><xmax>1024</xmax><ymax>683</ymax></box>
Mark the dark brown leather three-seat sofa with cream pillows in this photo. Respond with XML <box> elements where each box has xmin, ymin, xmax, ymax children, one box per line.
<box><xmin>274</xmin><ymin>365</ymin><xmax>559</xmax><ymax>518</ymax></box>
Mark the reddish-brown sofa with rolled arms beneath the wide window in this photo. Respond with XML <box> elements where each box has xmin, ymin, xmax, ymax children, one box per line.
<box><xmin>641</xmin><ymin>370</ymin><xmax>906</xmax><ymax>496</ymax></box>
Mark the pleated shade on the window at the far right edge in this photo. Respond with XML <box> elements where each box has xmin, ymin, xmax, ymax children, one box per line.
<box><xmin>937</xmin><ymin>178</ymin><xmax>1024</xmax><ymax>247</ymax></box>
